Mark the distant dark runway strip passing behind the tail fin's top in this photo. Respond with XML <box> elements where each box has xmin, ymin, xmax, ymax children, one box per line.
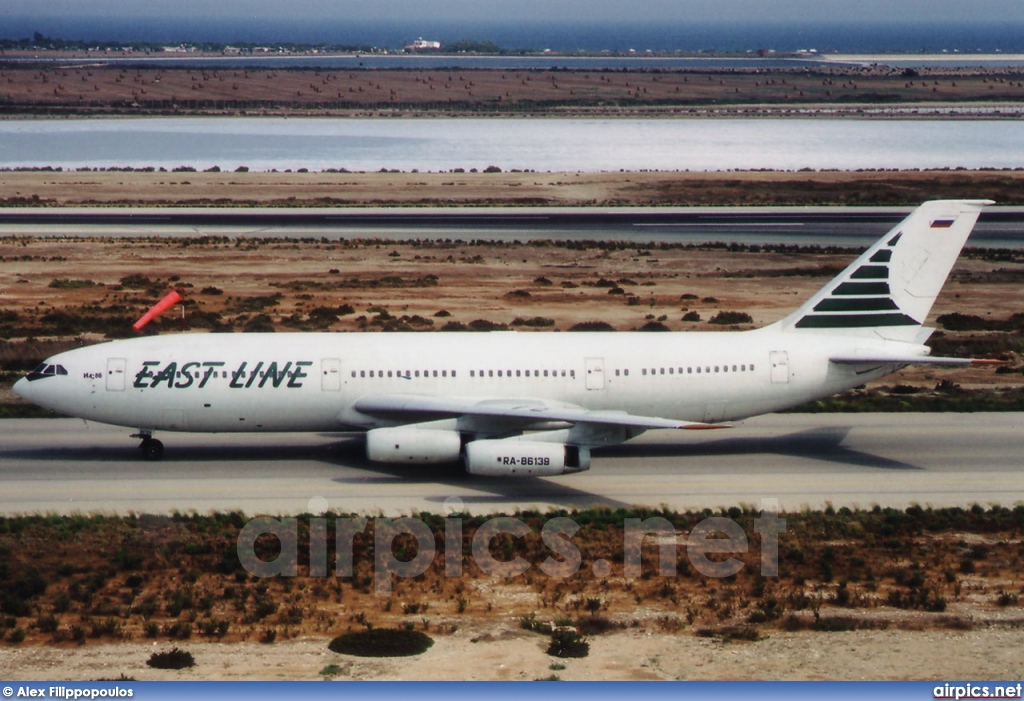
<box><xmin>6</xmin><ymin>207</ymin><xmax>1024</xmax><ymax>249</ymax></box>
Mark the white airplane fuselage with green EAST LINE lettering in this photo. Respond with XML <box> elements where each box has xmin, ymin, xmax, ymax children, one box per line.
<box><xmin>16</xmin><ymin>327</ymin><xmax>897</xmax><ymax>432</ymax></box>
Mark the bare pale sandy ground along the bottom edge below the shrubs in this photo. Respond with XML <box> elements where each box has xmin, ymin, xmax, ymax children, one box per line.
<box><xmin>0</xmin><ymin>622</ymin><xmax>1024</xmax><ymax>681</ymax></box>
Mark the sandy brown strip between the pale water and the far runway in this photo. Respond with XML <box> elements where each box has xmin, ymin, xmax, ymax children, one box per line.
<box><xmin>6</xmin><ymin>170</ymin><xmax>1024</xmax><ymax>207</ymax></box>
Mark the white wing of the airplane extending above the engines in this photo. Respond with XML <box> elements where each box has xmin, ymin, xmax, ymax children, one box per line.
<box><xmin>355</xmin><ymin>395</ymin><xmax>729</xmax><ymax>429</ymax></box>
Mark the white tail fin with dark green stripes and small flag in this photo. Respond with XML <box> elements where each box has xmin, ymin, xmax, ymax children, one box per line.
<box><xmin>776</xmin><ymin>200</ymin><xmax>992</xmax><ymax>342</ymax></box>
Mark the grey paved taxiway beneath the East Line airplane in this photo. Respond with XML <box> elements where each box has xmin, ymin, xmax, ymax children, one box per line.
<box><xmin>0</xmin><ymin>413</ymin><xmax>1024</xmax><ymax>516</ymax></box>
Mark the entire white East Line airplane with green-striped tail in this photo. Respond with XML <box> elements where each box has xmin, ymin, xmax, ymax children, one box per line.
<box><xmin>14</xmin><ymin>201</ymin><xmax>997</xmax><ymax>476</ymax></box>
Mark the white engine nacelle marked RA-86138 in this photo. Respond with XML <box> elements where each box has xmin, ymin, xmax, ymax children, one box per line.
<box><xmin>466</xmin><ymin>439</ymin><xmax>590</xmax><ymax>477</ymax></box>
